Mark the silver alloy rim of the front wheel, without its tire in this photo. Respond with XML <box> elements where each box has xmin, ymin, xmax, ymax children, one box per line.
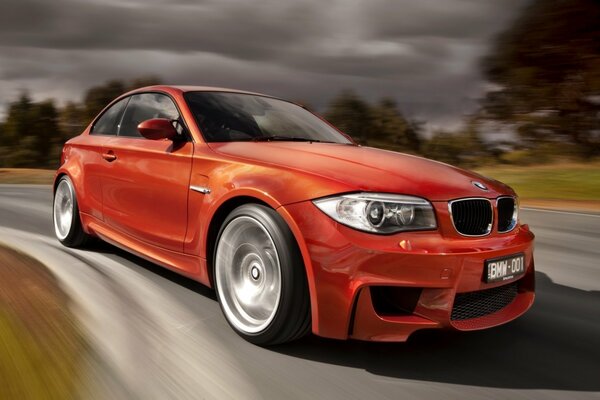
<box><xmin>215</xmin><ymin>216</ymin><xmax>281</xmax><ymax>334</ymax></box>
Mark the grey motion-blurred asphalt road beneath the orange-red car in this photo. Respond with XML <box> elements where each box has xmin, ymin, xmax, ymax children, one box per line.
<box><xmin>0</xmin><ymin>185</ymin><xmax>600</xmax><ymax>400</ymax></box>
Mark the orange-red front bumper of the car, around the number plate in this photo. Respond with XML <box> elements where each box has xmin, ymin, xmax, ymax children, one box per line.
<box><xmin>280</xmin><ymin>201</ymin><xmax>535</xmax><ymax>341</ymax></box>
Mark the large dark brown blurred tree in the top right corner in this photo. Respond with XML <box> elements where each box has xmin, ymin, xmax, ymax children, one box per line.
<box><xmin>484</xmin><ymin>0</ymin><xmax>600</xmax><ymax>157</ymax></box>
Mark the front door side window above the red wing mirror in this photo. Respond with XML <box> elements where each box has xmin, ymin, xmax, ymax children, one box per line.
<box><xmin>119</xmin><ymin>93</ymin><xmax>179</xmax><ymax>137</ymax></box>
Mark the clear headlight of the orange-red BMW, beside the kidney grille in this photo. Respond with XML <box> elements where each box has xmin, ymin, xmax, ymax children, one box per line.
<box><xmin>313</xmin><ymin>193</ymin><xmax>437</xmax><ymax>233</ymax></box>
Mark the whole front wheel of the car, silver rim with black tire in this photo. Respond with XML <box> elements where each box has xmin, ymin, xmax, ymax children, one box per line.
<box><xmin>214</xmin><ymin>204</ymin><xmax>310</xmax><ymax>345</ymax></box>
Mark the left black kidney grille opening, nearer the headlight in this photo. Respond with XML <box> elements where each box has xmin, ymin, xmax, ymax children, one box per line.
<box><xmin>450</xmin><ymin>199</ymin><xmax>494</xmax><ymax>236</ymax></box>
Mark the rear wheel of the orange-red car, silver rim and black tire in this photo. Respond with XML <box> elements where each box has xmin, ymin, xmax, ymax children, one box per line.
<box><xmin>52</xmin><ymin>175</ymin><xmax>90</xmax><ymax>247</ymax></box>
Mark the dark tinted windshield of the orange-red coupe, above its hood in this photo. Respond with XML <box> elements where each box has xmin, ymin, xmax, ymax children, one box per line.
<box><xmin>185</xmin><ymin>92</ymin><xmax>351</xmax><ymax>144</ymax></box>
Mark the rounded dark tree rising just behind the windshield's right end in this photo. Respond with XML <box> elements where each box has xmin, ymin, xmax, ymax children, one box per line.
<box><xmin>325</xmin><ymin>90</ymin><xmax>374</xmax><ymax>144</ymax></box>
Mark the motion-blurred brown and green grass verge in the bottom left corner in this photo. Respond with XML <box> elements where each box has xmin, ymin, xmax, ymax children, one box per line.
<box><xmin>0</xmin><ymin>246</ymin><xmax>86</xmax><ymax>399</ymax></box>
